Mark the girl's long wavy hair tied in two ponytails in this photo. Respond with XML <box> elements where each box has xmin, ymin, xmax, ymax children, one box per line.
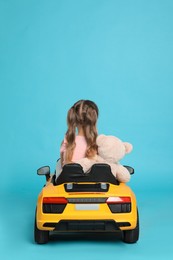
<box><xmin>64</xmin><ymin>100</ymin><xmax>99</xmax><ymax>163</ymax></box>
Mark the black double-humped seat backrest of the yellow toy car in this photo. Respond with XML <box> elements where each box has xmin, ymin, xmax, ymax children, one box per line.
<box><xmin>55</xmin><ymin>163</ymin><xmax>119</xmax><ymax>185</ymax></box>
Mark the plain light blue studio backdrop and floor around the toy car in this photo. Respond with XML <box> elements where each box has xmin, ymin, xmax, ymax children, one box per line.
<box><xmin>0</xmin><ymin>0</ymin><xmax>173</xmax><ymax>260</ymax></box>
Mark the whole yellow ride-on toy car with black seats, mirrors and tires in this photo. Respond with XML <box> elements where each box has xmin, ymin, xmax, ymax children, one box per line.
<box><xmin>34</xmin><ymin>164</ymin><xmax>139</xmax><ymax>244</ymax></box>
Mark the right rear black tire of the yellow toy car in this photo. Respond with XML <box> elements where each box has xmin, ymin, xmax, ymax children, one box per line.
<box><xmin>123</xmin><ymin>208</ymin><xmax>139</xmax><ymax>244</ymax></box>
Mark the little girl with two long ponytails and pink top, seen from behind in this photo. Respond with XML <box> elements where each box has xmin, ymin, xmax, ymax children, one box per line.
<box><xmin>60</xmin><ymin>100</ymin><xmax>99</xmax><ymax>166</ymax></box>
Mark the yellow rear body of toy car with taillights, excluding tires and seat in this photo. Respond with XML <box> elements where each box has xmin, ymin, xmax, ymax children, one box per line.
<box><xmin>36</xmin><ymin>165</ymin><xmax>138</xmax><ymax>242</ymax></box>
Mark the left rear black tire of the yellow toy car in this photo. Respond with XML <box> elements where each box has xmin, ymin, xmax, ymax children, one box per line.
<box><xmin>34</xmin><ymin>209</ymin><xmax>49</xmax><ymax>244</ymax></box>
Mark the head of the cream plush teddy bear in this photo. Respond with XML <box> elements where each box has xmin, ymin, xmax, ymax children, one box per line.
<box><xmin>96</xmin><ymin>135</ymin><xmax>133</xmax><ymax>163</ymax></box>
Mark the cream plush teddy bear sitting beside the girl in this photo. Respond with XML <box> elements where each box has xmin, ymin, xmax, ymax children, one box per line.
<box><xmin>76</xmin><ymin>134</ymin><xmax>133</xmax><ymax>183</ymax></box>
